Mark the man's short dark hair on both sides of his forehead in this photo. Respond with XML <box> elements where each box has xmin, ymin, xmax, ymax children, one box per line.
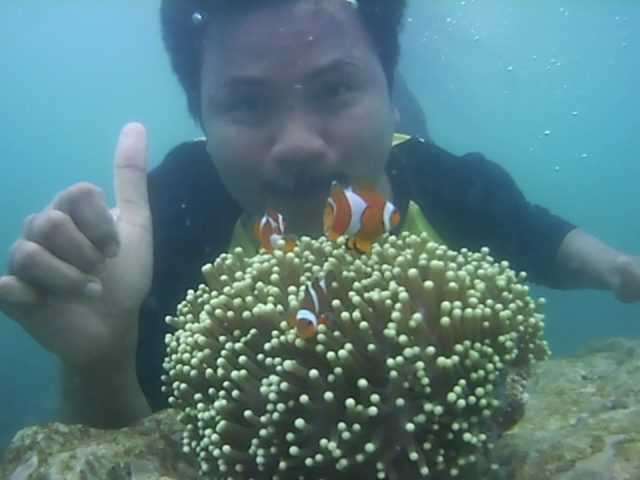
<box><xmin>160</xmin><ymin>0</ymin><xmax>406</xmax><ymax>123</ymax></box>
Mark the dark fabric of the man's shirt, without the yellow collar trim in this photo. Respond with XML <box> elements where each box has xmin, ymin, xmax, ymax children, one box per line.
<box><xmin>137</xmin><ymin>139</ymin><xmax>574</xmax><ymax>410</ymax></box>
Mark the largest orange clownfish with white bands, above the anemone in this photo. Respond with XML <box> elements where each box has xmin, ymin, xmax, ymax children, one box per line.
<box><xmin>323</xmin><ymin>181</ymin><xmax>400</xmax><ymax>253</ymax></box>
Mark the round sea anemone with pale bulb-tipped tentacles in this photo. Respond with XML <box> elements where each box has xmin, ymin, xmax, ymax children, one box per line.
<box><xmin>164</xmin><ymin>234</ymin><xmax>548</xmax><ymax>480</ymax></box>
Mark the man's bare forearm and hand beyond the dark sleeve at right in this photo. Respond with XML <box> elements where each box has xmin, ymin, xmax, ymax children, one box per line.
<box><xmin>556</xmin><ymin>228</ymin><xmax>640</xmax><ymax>302</ymax></box>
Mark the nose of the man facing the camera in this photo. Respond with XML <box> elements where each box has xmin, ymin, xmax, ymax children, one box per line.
<box><xmin>271</xmin><ymin>112</ymin><xmax>327</xmax><ymax>166</ymax></box>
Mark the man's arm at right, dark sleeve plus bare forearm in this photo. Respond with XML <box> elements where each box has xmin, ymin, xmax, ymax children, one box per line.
<box><xmin>396</xmin><ymin>140</ymin><xmax>640</xmax><ymax>302</ymax></box>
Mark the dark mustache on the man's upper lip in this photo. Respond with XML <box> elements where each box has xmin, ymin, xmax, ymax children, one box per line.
<box><xmin>262</xmin><ymin>169</ymin><xmax>348</xmax><ymax>197</ymax></box>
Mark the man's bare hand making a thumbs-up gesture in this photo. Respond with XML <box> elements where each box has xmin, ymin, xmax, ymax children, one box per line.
<box><xmin>0</xmin><ymin>124</ymin><xmax>153</xmax><ymax>368</ymax></box>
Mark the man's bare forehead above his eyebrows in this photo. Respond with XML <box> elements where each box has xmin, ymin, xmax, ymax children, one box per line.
<box><xmin>200</xmin><ymin>0</ymin><xmax>372</xmax><ymax>81</ymax></box>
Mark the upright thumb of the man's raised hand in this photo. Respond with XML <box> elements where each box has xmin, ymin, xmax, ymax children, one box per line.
<box><xmin>113</xmin><ymin>123</ymin><xmax>151</xmax><ymax>224</ymax></box>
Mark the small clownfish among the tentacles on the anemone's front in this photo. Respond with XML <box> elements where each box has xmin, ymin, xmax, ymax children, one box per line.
<box><xmin>288</xmin><ymin>272</ymin><xmax>334</xmax><ymax>340</ymax></box>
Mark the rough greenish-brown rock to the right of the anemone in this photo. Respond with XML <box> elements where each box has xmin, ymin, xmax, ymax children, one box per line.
<box><xmin>494</xmin><ymin>339</ymin><xmax>640</xmax><ymax>480</ymax></box>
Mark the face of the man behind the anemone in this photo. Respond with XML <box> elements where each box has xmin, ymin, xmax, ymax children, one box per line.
<box><xmin>201</xmin><ymin>0</ymin><xmax>394</xmax><ymax>235</ymax></box>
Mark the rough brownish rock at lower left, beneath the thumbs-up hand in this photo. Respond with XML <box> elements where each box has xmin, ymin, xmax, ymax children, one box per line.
<box><xmin>0</xmin><ymin>410</ymin><xmax>200</xmax><ymax>480</ymax></box>
